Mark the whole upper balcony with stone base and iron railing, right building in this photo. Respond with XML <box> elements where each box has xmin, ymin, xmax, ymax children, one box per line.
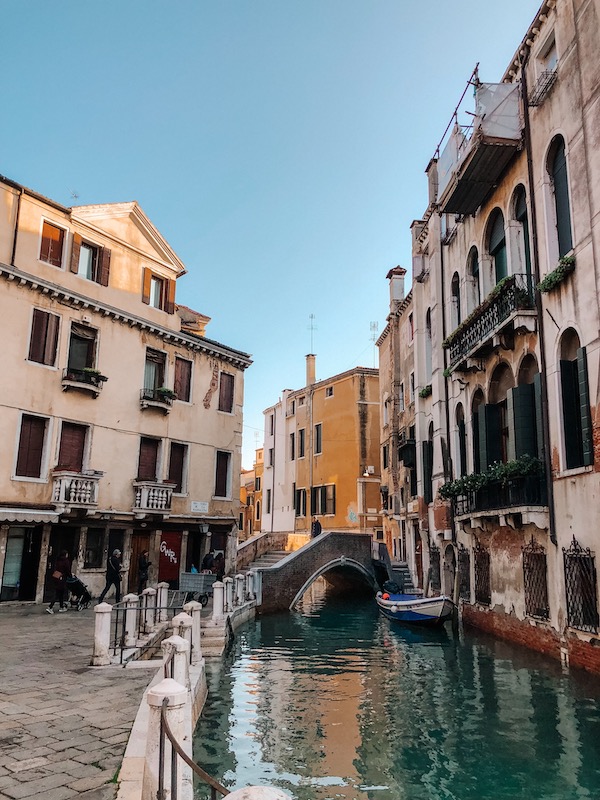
<box><xmin>443</xmin><ymin>275</ymin><xmax>536</xmax><ymax>370</ymax></box>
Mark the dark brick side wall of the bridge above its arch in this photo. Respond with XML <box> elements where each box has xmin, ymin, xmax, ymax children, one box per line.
<box><xmin>259</xmin><ymin>532</ymin><xmax>374</xmax><ymax>614</ymax></box>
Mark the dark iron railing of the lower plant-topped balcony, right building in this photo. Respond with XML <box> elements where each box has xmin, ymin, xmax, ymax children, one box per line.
<box><xmin>452</xmin><ymin>475</ymin><xmax>548</xmax><ymax>516</ymax></box>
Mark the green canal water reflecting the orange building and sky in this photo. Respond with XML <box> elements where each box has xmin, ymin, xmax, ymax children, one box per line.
<box><xmin>194</xmin><ymin>588</ymin><xmax>600</xmax><ymax>800</ymax></box>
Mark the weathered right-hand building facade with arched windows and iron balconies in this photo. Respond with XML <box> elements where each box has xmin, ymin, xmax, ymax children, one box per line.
<box><xmin>382</xmin><ymin>0</ymin><xmax>600</xmax><ymax>671</ymax></box>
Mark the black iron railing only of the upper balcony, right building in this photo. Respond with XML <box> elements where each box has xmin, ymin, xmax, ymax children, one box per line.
<box><xmin>444</xmin><ymin>275</ymin><xmax>534</xmax><ymax>367</ymax></box>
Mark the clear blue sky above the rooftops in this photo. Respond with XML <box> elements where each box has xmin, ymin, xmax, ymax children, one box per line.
<box><xmin>0</xmin><ymin>0</ymin><xmax>540</xmax><ymax>468</ymax></box>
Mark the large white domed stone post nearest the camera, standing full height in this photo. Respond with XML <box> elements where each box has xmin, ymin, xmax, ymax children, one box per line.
<box><xmin>143</xmin><ymin>678</ymin><xmax>188</xmax><ymax>800</ymax></box>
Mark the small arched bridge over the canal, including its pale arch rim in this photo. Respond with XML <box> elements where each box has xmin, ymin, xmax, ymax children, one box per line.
<box><xmin>240</xmin><ymin>531</ymin><xmax>378</xmax><ymax>613</ymax></box>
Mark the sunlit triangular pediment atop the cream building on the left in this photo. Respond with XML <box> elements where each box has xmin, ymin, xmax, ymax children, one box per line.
<box><xmin>71</xmin><ymin>201</ymin><xmax>186</xmax><ymax>275</ymax></box>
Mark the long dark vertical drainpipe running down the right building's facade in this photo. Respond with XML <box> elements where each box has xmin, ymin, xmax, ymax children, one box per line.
<box><xmin>521</xmin><ymin>49</ymin><xmax>558</xmax><ymax>545</ymax></box>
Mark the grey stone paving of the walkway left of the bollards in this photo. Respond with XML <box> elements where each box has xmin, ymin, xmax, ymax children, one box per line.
<box><xmin>0</xmin><ymin>604</ymin><xmax>154</xmax><ymax>800</ymax></box>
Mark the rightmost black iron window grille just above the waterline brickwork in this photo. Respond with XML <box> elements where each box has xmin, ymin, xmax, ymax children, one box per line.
<box><xmin>563</xmin><ymin>536</ymin><xmax>598</xmax><ymax>633</ymax></box>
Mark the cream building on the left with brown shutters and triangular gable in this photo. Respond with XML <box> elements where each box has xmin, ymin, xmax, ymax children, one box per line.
<box><xmin>0</xmin><ymin>173</ymin><xmax>250</xmax><ymax>602</ymax></box>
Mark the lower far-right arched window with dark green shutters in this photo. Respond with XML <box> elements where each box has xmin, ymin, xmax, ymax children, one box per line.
<box><xmin>560</xmin><ymin>328</ymin><xmax>594</xmax><ymax>469</ymax></box>
